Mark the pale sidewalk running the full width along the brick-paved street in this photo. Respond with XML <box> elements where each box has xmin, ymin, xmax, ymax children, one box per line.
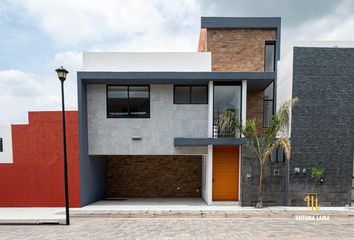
<box><xmin>0</xmin><ymin>201</ymin><xmax>354</xmax><ymax>224</ymax></box>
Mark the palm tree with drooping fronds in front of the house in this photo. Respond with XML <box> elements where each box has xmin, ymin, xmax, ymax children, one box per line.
<box><xmin>217</xmin><ymin>98</ymin><xmax>298</xmax><ymax>208</ymax></box>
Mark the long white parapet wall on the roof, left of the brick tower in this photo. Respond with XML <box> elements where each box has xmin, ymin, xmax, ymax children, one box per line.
<box><xmin>83</xmin><ymin>52</ymin><xmax>211</xmax><ymax>72</ymax></box>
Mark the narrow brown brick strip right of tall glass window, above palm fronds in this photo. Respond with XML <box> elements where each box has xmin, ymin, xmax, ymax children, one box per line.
<box><xmin>246</xmin><ymin>91</ymin><xmax>266</xmax><ymax>133</ymax></box>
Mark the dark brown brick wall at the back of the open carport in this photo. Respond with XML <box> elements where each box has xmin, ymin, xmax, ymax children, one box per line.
<box><xmin>107</xmin><ymin>155</ymin><xmax>202</xmax><ymax>198</ymax></box>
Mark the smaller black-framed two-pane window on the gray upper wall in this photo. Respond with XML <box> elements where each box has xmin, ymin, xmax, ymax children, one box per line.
<box><xmin>173</xmin><ymin>85</ymin><xmax>208</xmax><ymax>104</ymax></box>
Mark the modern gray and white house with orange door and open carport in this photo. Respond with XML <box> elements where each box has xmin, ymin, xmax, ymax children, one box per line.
<box><xmin>77</xmin><ymin>17</ymin><xmax>281</xmax><ymax>205</ymax></box>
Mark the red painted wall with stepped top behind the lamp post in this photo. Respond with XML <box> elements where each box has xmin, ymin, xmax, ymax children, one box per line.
<box><xmin>0</xmin><ymin>111</ymin><xmax>80</xmax><ymax>207</ymax></box>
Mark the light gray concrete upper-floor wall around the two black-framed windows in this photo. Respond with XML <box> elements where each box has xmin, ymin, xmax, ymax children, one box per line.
<box><xmin>87</xmin><ymin>84</ymin><xmax>208</xmax><ymax>155</ymax></box>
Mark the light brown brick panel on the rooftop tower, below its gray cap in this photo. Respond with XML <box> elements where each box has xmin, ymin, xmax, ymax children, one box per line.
<box><xmin>207</xmin><ymin>29</ymin><xmax>276</xmax><ymax>72</ymax></box>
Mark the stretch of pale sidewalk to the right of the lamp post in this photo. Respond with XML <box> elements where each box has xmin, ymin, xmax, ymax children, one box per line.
<box><xmin>71</xmin><ymin>199</ymin><xmax>354</xmax><ymax>218</ymax></box>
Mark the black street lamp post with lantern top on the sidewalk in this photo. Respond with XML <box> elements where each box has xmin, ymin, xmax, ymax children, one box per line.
<box><xmin>55</xmin><ymin>66</ymin><xmax>70</xmax><ymax>225</ymax></box>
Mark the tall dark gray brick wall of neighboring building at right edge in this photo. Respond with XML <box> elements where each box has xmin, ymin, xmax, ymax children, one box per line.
<box><xmin>289</xmin><ymin>47</ymin><xmax>354</xmax><ymax>206</ymax></box>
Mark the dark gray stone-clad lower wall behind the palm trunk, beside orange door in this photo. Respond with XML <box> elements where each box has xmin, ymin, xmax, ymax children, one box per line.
<box><xmin>241</xmin><ymin>146</ymin><xmax>285</xmax><ymax>206</ymax></box>
